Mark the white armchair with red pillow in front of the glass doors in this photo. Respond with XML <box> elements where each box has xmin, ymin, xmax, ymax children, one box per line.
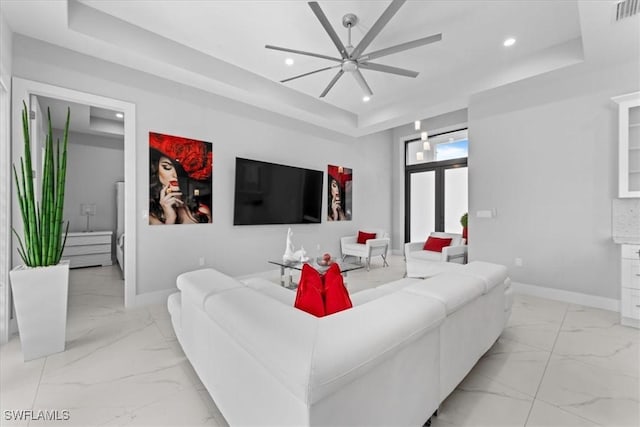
<box><xmin>404</xmin><ymin>232</ymin><xmax>467</xmax><ymax>277</ymax></box>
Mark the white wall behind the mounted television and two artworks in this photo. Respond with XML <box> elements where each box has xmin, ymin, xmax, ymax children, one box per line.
<box><xmin>14</xmin><ymin>36</ymin><xmax>391</xmax><ymax>294</ymax></box>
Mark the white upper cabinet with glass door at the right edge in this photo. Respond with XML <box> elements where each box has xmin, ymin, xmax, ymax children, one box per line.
<box><xmin>613</xmin><ymin>92</ymin><xmax>640</xmax><ymax>197</ymax></box>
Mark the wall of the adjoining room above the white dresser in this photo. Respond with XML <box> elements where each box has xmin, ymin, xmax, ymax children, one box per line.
<box><xmin>54</xmin><ymin>131</ymin><xmax>124</xmax><ymax>235</ymax></box>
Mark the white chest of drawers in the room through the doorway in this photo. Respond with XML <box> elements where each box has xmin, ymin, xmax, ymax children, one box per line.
<box><xmin>62</xmin><ymin>231</ymin><xmax>113</xmax><ymax>268</ymax></box>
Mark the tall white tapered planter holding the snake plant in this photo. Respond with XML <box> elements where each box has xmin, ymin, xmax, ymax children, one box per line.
<box><xmin>9</xmin><ymin>261</ymin><xmax>69</xmax><ymax>362</ymax></box>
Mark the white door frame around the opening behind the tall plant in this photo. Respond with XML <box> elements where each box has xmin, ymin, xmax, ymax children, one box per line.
<box><xmin>11</xmin><ymin>77</ymin><xmax>138</xmax><ymax>308</ymax></box>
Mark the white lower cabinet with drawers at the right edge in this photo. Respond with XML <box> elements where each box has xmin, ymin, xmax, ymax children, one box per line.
<box><xmin>620</xmin><ymin>245</ymin><xmax>640</xmax><ymax>328</ymax></box>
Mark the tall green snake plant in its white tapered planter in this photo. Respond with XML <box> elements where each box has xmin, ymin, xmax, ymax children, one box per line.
<box><xmin>9</xmin><ymin>102</ymin><xmax>71</xmax><ymax>361</ymax></box>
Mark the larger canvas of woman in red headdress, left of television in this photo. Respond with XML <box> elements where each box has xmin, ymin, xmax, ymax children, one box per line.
<box><xmin>149</xmin><ymin>132</ymin><xmax>213</xmax><ymax>225</ymax></box>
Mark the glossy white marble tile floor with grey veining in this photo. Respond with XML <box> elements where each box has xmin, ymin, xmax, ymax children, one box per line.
<box><xmin>0</xmin><ymin>257</ymin><xmax>640</xmax><ymax>427</ymax></box>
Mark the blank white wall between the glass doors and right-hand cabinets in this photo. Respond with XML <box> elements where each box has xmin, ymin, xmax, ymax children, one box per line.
<box><xmin>469</xmin><ymin>61</ymin><xmax>640</xmax><ymax>299</ymax></box>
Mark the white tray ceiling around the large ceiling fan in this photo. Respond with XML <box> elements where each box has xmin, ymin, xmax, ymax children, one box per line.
<box><xmin>0</xmin><ymin>0</ymin><xmax>640</xmax><ymax>136</ymax></box>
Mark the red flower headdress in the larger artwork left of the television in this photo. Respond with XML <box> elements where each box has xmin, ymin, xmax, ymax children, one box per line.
<box><xmin>149</xmin><ymin>132</ymin><xmax>213</xmax><ymax>181</ymax></box>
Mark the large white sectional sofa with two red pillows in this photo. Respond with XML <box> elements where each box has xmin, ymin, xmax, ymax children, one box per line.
<box><xmin>168</xmin><ymin>262</ymin><xmax>511</xmax><ymax>426</ymax></box>
